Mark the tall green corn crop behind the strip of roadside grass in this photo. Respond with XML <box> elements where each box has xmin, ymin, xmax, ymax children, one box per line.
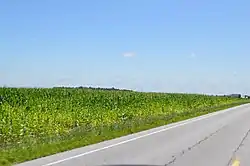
<box><xmin>0</xmin><ymin>88</ymin><xmax>246</xmax><ymax>145</ymax></box>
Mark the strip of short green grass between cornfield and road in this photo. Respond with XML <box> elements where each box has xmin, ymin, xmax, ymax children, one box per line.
<box><xmin>0</xmin><ymin>99</ymin><xmax>250</xmax><ymax>166</ymax></box>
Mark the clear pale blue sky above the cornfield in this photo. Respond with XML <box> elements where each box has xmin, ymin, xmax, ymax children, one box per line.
<box><xmin>0</xmin><ymin>0</ymin><xmax>250</xmax><ymax>94</ymax></box>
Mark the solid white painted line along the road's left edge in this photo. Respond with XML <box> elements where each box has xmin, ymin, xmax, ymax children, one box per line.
<box><xmin>42</xmin><ymin>104</ymin><xmax>248</xmax><ymax>166</ymax></box>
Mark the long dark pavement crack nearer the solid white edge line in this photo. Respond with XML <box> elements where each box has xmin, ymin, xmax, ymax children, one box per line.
<box><xmin>164</xmin><ymin>126</ymin><xmax>224</xmax><ymax>166</ymax></box>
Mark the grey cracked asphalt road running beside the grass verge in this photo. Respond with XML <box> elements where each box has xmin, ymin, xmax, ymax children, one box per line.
<box><xmin>18</xmin><ymin>104</ymin><xmax>250</xmax><ymax>166</ymax></box>
